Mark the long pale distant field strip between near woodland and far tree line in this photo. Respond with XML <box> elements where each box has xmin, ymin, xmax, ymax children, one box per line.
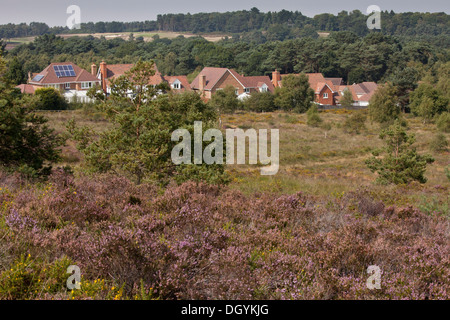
<box><xmin>6</xmin><ymin>31</ymin><xmax>230</xmax><ymax>50</ymax></box>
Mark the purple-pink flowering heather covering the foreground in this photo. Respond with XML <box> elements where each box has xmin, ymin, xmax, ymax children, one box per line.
<box><xmin>0</xmin><ymin>171</ymin><xmax>450</xmax><ymax>299</ymax></box>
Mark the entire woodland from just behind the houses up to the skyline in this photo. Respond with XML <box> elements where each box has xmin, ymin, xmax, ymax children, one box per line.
<box><xmin>0</xmin><ymin>8</ymin><xmax>450</xmax><ymax>84</ymax></box>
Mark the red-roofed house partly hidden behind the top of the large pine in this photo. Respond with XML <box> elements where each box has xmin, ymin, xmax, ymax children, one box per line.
<box><xmin>95</xmin><ymin>61</ymin><xmax>191</xmax><ymax>94</ymax></box>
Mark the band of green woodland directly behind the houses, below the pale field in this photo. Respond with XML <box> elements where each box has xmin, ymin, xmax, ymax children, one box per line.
<box><xmin>0</xmin><ymin>31</ymin><xmax>449</xmax><ymax>84</ymax></box>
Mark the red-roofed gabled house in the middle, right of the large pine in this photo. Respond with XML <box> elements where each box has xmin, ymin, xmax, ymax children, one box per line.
<box><xmin>191</xmin><ymin>67</ymin><xmax>274</xmax><ymax>100</ymax></box>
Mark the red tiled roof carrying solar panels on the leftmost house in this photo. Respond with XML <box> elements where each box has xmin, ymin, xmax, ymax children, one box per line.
<box><xmin>29</xmin><ymin>62</ymin><xmax>99</xmax><ymax>85</ymax></box>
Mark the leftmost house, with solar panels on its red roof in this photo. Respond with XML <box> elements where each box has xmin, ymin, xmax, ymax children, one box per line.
<box><xmin>26</xmin><ymin>62</ymin><xmax>100</xmax><ymax>102</ymax></box>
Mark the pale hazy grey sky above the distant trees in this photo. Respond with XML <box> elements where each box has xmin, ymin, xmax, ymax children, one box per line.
<box><xmin>0</xmin><ymin>0</ymin><xmax>450</xmax><ymax>26</ymax></box>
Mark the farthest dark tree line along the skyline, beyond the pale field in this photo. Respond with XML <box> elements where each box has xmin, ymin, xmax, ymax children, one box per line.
<box><xmin>0</xmin><ymin>7</ymin><xmax>449</xmax><ymax>41</ymax></box>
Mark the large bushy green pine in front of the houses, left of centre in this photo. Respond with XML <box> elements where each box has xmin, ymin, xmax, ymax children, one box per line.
<box><xmin>68</xmin><ymin>61</ymin><xmax>225</xmax><ymax>184</ymax></box>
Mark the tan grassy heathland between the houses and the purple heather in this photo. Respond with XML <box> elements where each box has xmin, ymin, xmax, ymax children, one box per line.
<box><xmin>45</xmin><ymin>110</ymin><xmax>450</xmax><ymax>211</ymax></box>
